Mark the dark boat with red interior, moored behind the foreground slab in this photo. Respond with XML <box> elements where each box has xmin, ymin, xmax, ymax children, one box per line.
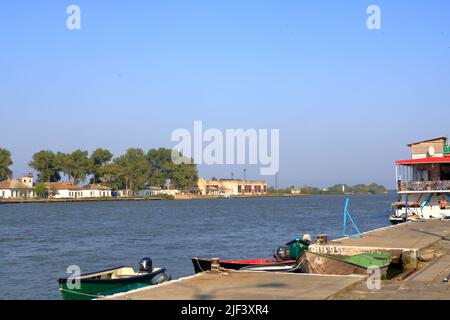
<box><xmin>192</xmin><ymin>258</ymin><xmax>295</xmax><ymax>273</ymax></box>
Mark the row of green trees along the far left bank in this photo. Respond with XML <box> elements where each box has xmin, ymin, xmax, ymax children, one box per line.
<box><xmin>0</xmin><ymin>148</ymin><xmax>198</xmax><ymax>192</ymax></box>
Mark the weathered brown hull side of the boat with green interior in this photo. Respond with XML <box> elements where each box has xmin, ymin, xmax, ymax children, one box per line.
<box><xmin>301</xmin><ymin>251</ymin><xmax>389</xmax><ymax>277</ymax></box>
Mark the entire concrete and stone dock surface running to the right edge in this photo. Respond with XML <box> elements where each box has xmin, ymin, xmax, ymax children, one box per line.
<box><xmin>104</xmin><ymin>220</ymin><xmax>450</xmax><ymax>300</ymax></box>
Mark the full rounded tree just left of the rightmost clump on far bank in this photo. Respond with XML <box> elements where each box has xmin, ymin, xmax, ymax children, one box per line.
<box><xmin>114</xmin><ymin>148</ymin><xmax>150</xmax><ymax>194</ymax></box>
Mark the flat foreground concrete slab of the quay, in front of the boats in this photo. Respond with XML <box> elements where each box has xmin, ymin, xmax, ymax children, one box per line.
<box><xmin>105</xmin><ymin>270</ymin><xmax>366</xmax><ymax>300</ymax></box>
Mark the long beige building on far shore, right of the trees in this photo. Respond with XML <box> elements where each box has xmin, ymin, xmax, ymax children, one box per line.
<box><xmin>198</xmin><ymin>178</ymin><xmax>267</xmax><ymax>196</ymax></box>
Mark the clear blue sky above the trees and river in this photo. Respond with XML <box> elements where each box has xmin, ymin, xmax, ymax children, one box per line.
<box><xmin>0</xmin><ymin>0</ymin><xmax>450</xmax><ymax>187</ymax></box>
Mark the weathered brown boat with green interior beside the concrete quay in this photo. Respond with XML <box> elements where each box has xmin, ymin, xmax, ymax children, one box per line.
<box><xmin>301</xmin><ymin>251</ymin><xmax>391</xmax><ymax>276</ymax></box>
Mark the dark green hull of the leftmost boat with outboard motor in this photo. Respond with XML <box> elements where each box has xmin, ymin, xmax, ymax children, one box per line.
<box><xmin>58</xmin><ymin>268</ymin><xmax>170</xmax><ymax>300</ymax></box>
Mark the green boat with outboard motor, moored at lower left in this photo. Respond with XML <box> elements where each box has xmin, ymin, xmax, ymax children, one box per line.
<box><xmin>58</xmin><ymin>258</ymin><xmax>171</xmax><ymax>300</ymax></box>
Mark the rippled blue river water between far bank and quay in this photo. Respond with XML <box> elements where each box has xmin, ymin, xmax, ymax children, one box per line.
<box><xmin>0</xmin><ymin>194</ymin><xmax>395</xmax><ymax>299</ymax></box>
